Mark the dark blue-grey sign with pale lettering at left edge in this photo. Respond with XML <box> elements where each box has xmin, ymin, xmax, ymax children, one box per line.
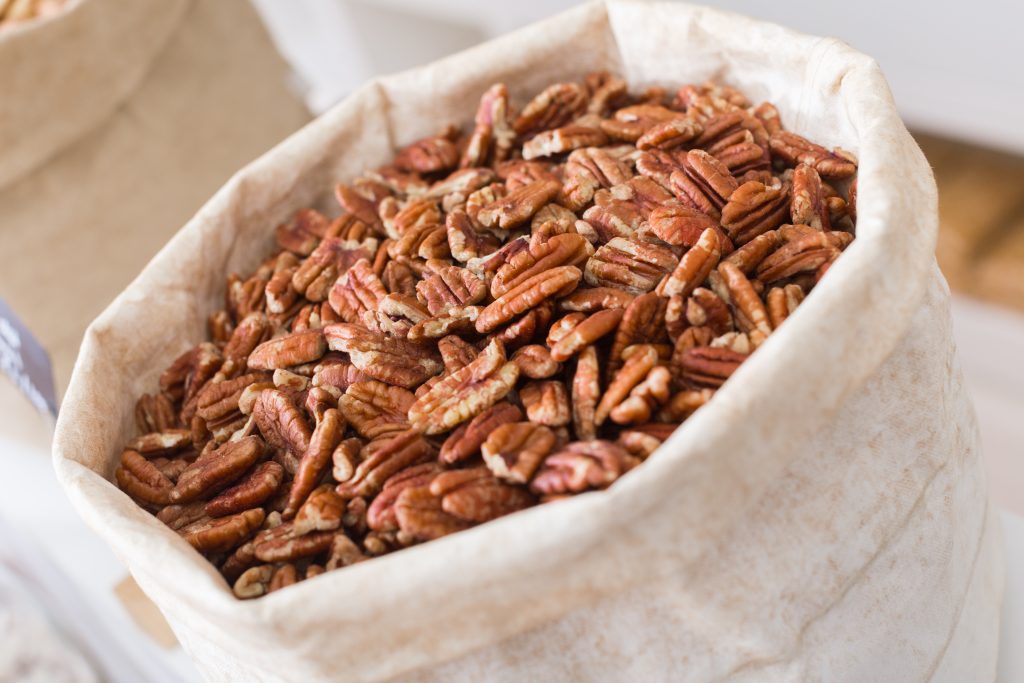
<box><xmin>0</xmin><ymin>299</ymin><xmax>57</xmax><ymax>417</ymax></box>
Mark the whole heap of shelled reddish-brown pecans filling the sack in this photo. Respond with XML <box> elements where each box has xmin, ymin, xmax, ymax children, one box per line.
<box><xmin>116</xmin><ymin>73</ymin><xmax>856</xmax><ymax>598</ymax></box>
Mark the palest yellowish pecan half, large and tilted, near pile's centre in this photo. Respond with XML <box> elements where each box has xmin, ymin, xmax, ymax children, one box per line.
<box><xmin>409</xmin><ymin>340</ymin><xmax>519</xmax><ymax>434</ymax></box>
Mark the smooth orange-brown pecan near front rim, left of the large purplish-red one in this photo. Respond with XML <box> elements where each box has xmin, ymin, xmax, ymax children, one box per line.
<box><xmin>429</xmin><ymin>467</ymin><xmax>535</xmax><ymax>523</ymax></box>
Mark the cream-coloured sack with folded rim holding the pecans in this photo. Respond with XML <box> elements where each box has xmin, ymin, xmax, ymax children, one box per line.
<box><xmin>54</xmin><ymin>1</ymin><xmax>1002</xmax><ymax>681</ymax></box>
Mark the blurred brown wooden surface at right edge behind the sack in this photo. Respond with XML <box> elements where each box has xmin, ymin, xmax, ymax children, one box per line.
<box><xmin>915</xmin><ymin>134</ymin><xmax>1024</xmax><ymax>311</ymax></box>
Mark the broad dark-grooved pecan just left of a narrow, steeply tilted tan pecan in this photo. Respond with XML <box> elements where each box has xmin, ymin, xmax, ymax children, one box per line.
<box><xmin>584</xmin><ymin>238</ymin><xmax>678</xmax><ymax>295</ymax></box>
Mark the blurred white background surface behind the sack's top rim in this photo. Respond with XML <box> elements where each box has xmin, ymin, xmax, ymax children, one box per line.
<box><xmin>254</xmin><ymin>0</ymin><xmax>1024</xmax><ymax>153</ymax></box>
